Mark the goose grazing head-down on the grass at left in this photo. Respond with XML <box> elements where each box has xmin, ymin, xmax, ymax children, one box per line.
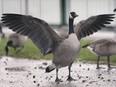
<box><xmin>5</xmin><ymin>33</ymin><xmax>26</xmax><ymax>55</ymax></box>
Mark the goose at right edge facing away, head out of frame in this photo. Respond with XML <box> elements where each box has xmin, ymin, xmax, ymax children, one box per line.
<box><xmin>82</xmin><ymin>39</ymin><xmax>116</xmax><ymax>69</ymax></box>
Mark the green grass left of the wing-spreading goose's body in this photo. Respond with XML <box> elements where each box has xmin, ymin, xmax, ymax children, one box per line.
<box><xmin>0</xmin><ymin>38</ymin><xmax>52</xmax><ymax>59</ymax></box>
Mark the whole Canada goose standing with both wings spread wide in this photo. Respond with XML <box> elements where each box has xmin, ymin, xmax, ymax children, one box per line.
<box><xmin>1</xmin><ymin>12</ymin><xmax>114</xmax><ymax>82</ymax></box>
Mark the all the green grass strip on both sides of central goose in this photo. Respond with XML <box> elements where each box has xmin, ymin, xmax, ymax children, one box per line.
<box><xmin>0</xmin><ymin>38</ymin><xmax>116</xmax><ymax>64</ymax></box>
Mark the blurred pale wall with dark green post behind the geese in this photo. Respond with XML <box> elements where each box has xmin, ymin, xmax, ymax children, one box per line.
<box><xmin>0</xmin><ymin>0</ymin><xmax>116</xmax><ymax>26</ymax></box>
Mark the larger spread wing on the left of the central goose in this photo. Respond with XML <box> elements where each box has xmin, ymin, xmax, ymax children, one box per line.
<box><xmin>1</xmin><ymin>14</ymin><xmax>62</xmax><ymax>54</ymax></box>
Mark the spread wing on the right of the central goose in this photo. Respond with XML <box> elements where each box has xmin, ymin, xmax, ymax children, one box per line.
<box><xmin>75</xmin><ymin>14</ymin><xmax>114</xmax><ymax>40</ymax></box>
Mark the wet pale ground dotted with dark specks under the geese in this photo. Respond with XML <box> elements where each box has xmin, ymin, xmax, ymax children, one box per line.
<box><xmin>0</xmin><ymin>57</ymin><xmax>116</xmax><ymax>87</ymax></box>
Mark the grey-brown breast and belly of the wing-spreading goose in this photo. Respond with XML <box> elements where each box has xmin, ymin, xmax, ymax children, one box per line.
<box><xmin>53</xmin><ymin>34</ymin><xmax>80</xmax><ymax>68</ymax></box>
